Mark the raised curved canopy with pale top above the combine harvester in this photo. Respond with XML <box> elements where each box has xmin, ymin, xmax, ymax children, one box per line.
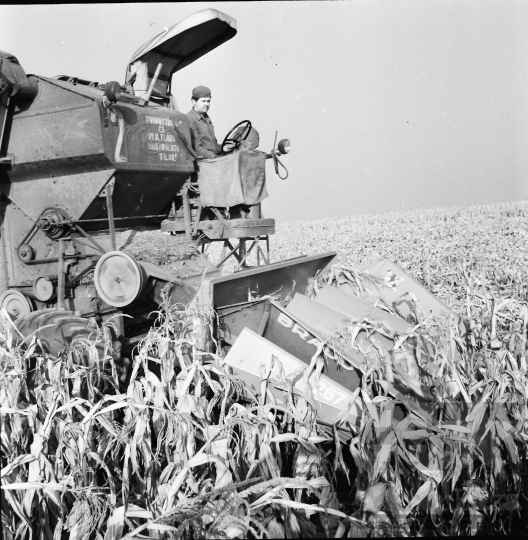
<box><xmin>126</xmin><ymin>9</ymin><xmax>237</xmax><ymax>97</ymax></box>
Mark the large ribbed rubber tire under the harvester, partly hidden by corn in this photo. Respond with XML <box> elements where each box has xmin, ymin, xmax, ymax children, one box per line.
<box><xmin>15</xmin><ymin>309</ymin><xmax>107</xmax><ymax>358</ymax></box>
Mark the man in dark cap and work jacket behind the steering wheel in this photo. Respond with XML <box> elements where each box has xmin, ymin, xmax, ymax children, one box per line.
<box><xmin>187</xmin><ymin>86</ymin><xmax>220</xmax><ymax>159</ymax></box>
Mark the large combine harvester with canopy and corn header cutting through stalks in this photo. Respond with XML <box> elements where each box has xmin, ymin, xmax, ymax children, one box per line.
<box><xmin>0</xmin><ymin>9</ymin><xmax>449</xmax><ymax>430</ymax></box>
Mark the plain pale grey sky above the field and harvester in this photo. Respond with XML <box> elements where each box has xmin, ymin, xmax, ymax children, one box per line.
<box><xmin>0</xmin><ymin>0</ymin><xmax>528</xmax><ymax>221</ymax></box>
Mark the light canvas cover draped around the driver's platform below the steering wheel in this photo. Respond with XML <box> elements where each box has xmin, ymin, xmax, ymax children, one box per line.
<box><xmin>198</xmin><ymin>150</ymin><xmax>268</xmax><ymax>208</ymax></box>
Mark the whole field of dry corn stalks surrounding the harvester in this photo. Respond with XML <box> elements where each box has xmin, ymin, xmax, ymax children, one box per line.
<box><xmin>0</xmin><ymin>202</ymin><xmax>528</xmax><ymax>540</ymax></box>
